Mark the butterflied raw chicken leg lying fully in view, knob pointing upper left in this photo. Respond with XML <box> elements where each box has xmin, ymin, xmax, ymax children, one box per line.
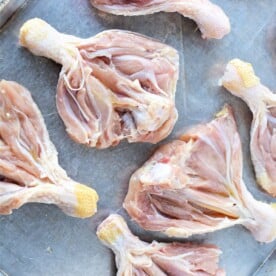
<box><xmin>20</xmin><ymin>18</ymin><xmax>179</xmax><ymax>148</ymax></box>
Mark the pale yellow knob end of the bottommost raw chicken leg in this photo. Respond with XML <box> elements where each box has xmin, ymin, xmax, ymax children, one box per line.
<box><xmin>97</xmin><ymin>214</ymin><xmax>128</xmax><ymax>244</ymax></box>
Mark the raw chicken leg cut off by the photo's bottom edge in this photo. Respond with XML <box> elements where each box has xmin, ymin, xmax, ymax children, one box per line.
<box><xmin>97</xmin><ymin>215</ymin><xmax>225</xmax><ymax>276</ymax></box>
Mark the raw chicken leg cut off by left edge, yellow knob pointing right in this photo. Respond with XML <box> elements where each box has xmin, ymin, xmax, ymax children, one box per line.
<box><xmin>0</xmin><ymin>80</ymin><xmax>98</xmax><ymax>218</ymax></box>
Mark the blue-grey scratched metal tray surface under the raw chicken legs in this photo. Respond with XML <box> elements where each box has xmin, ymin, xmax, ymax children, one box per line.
<box><xmin>0</xmin><ymin>0</ymin><xmax>276</xmax><ymax>276</ymax></box>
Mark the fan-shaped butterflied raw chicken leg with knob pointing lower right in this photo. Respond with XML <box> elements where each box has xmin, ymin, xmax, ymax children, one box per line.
<box><xmin>124</xmin><ymin>106</ymin><xmax>276</xmax><ymax>242</ymax></box>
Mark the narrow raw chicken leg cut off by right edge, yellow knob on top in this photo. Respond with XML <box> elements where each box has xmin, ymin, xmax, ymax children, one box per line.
<box><xmin>221</xmin><ymin>59</ymin><xmax>276</xmax><ymax>197</ymax></box>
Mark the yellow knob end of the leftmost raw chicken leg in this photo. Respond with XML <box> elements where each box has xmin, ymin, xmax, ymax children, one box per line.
<box><xmin>75</xmin><ymin>184</ymin><xmax>99</xmax><ymax>218</ymax></box>
